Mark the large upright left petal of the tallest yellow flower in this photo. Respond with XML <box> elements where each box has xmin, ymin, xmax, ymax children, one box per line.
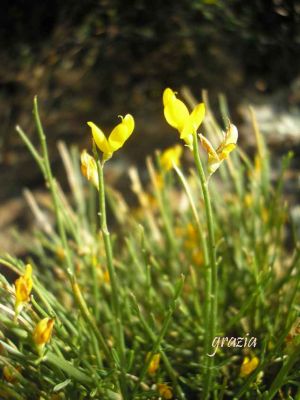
<box><xmin>163</xmin><ymin>88</ymin><xmax>189</xmax><ymax>132</ymax></box>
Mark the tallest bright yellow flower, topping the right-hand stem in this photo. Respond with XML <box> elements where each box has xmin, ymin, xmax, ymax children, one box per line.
<box><xmin>163</xmin><ymin>88</ymin><xmax>205</xmax><ymax>147</ymax></box>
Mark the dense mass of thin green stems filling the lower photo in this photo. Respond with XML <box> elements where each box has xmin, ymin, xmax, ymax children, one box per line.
<box><xmin>0</xmin><ymin>93</ymin><xmax>300</xmax><ymax>400</ymax></box>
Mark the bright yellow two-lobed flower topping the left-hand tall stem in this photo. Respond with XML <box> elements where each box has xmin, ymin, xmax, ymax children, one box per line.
<box><xmin>87</xmin><ymin>114</ymin><xmax>134</xmax><ymax>161</ymax></box>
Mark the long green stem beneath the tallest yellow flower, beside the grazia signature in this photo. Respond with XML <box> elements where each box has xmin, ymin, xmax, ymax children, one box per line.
<box><xmin>193</xmin><ymin>133</ymin><xmax>218</xmax><ymax>399</ymax></box>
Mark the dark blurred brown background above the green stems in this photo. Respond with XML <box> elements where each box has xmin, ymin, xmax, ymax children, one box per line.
<box><xmin>0</xmin><ymin>0</ymin><xmax>300</xmax><ymax>253</ymax></box>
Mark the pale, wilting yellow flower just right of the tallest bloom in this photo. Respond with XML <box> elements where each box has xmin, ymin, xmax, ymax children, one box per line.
<box><xmin>199</xmin><ymin>124</ymin><xmax>238</xmax><ymax>175</ymax></box>
